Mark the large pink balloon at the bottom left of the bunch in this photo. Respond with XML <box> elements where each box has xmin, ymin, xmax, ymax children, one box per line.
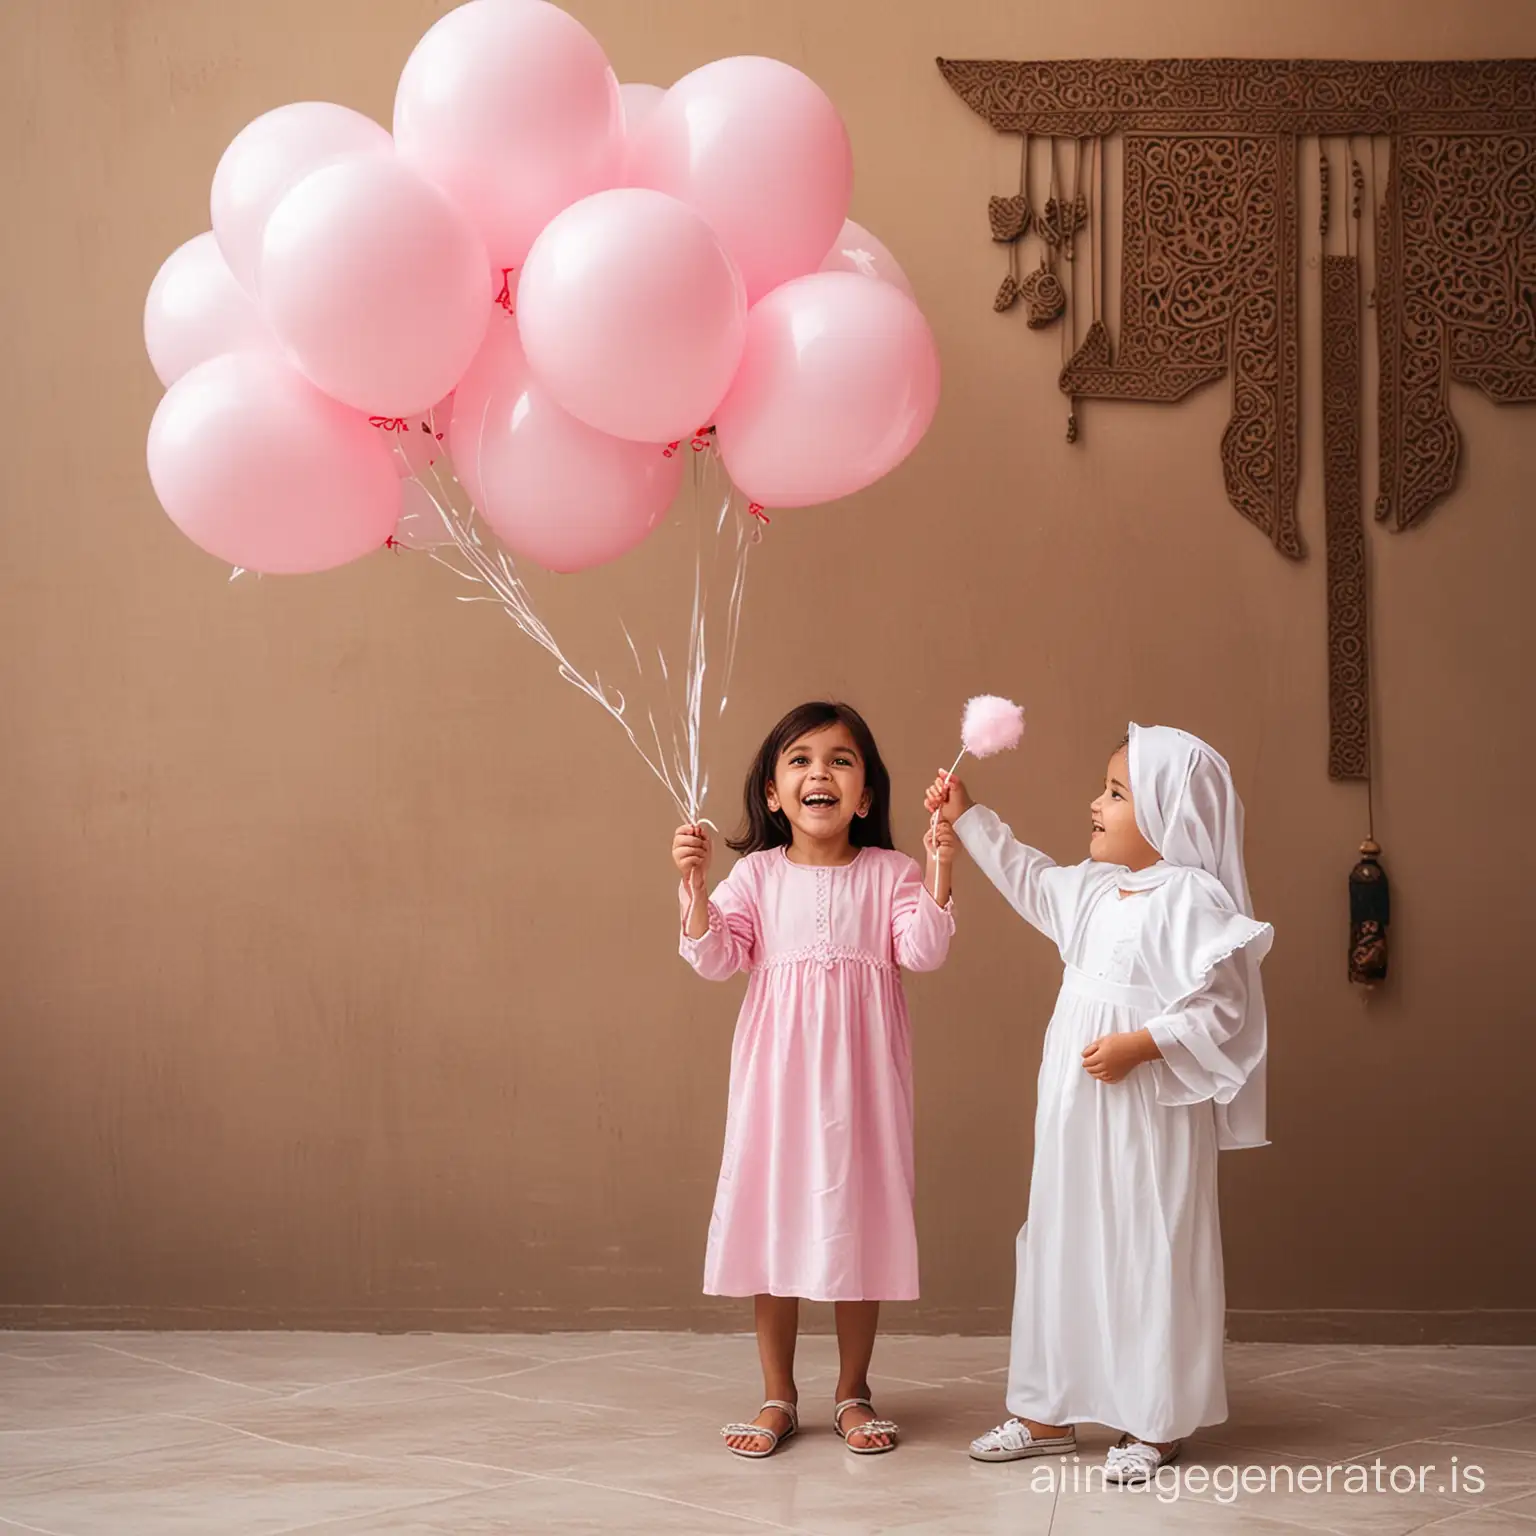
<box><xmin>149</xmin><ymin>352</ymin><xmax>399</xmax><ymax>574</ymax></box>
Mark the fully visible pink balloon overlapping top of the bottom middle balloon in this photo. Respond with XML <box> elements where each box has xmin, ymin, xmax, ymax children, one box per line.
<box><xmin>518</xmin><ymin>187</ymin><xmax>746</xmax><ymax>442</ymax></box>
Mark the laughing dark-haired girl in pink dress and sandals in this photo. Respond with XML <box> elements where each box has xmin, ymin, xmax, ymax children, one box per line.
<box><xmin>673</xmin><ymin>703</ymin><xmax>955</xmax><ymax>1458</ymax></box>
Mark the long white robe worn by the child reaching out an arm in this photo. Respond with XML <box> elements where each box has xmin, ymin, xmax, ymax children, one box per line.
<box><xmin>955</xmin><ymin>806</ymin><xmax>1273</xmax><ymax>1441</ymax></box>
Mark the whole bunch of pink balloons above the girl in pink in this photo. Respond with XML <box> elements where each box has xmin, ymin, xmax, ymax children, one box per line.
<box><xmin>144</xmin><ymin>0</ymin><xmax>938</xmax><ymax>571</ymax></box>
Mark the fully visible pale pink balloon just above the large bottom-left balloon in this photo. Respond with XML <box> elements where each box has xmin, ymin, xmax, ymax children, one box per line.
<box><xmin>260</xmin><ymin>155</ymin><xmax>492</xmax><ymax>416</ymax></box>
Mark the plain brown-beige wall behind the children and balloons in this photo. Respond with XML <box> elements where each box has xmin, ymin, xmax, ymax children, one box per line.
<box><xmin>0</xmin><ymin>0</ymin><xmax>1536</xmax><ymax>1338</ymax></box>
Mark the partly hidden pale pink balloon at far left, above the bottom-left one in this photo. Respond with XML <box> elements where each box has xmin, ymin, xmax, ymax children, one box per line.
<box><xmin>144</xmin><ymin>230</ymin><xmax>278</xmax><ymax>386</ymax></box>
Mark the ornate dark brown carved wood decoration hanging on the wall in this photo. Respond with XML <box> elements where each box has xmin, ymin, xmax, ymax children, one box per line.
<box><xmin>938</xmin><ymin>58</ymin><xmax>1536</xmax><ymax>777</ymax></box>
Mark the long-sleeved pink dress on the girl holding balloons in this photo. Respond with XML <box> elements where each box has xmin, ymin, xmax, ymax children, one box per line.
<box><xmin>682</xmin><ymin>848</ymin><xmax>954</xmax><ymax>1301</ymax></box>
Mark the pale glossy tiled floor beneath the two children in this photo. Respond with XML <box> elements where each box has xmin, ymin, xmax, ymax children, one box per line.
<box><xmin>0</xmin><ymin>1333</ymin><xmax>1536</xmax><ymax>1536</ymax></box>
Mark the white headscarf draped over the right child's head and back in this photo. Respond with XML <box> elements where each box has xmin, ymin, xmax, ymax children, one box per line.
<box><xmin>1121</xmin><ymin>725</ymin><xmax>1273</xmax><ymax>1147</ymax></box>
